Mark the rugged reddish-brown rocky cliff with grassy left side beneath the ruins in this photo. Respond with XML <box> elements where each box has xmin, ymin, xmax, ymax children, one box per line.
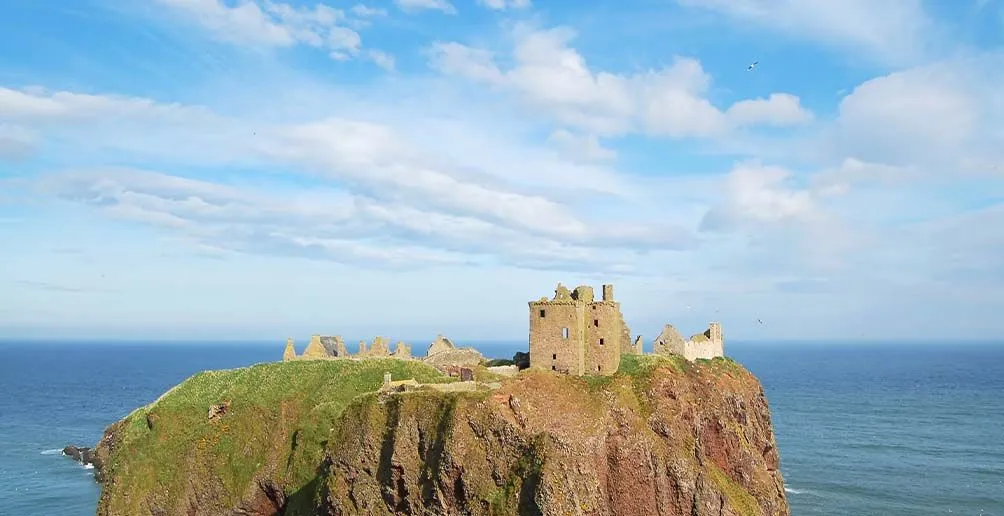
<box><xmin>96</xmin><ymin>355</ymin><xmax>789</xmax><ymax>516</ymax></box>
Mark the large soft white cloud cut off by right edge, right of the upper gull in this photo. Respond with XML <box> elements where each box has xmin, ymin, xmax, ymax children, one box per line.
<box><xmin>828</xmin><ymin>52</ymin><xmax>1004</xmax><ymax>173</ymax></box>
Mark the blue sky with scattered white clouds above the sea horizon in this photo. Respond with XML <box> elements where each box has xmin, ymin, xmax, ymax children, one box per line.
<box><xmin>0</xmin><ymin>0</ymin><xmax>1004</xmax><ymax>341</ymax></box>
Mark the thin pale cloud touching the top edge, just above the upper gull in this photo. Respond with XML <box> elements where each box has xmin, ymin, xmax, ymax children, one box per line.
<box><xmin>677</xmin><ymin>0</ymin><xmax>936</xmax><ymax>63</ymax></box>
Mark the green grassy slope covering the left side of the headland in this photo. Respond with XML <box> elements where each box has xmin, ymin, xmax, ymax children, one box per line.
<box><xmin>101</xmin><ymin>358</ymin><xmax>451</xmax><ymax>514</ymax></box>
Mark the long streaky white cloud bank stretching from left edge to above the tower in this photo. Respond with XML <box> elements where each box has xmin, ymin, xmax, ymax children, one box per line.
<box><xmin>0</xmin><ymin>84</ymin><xmax>689</xmax><ymax>268</ymax></box>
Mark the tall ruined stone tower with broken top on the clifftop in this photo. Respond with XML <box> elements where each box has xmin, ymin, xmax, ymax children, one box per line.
<box><xmin>529</xmin><ymin>283</ymin><xmax>635</xmax><ymax>375</ymax></box>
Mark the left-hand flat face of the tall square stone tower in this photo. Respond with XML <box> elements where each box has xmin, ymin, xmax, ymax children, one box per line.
<box><xmin>529</xmin><ymin>297</ymin><xmax>592</xmax><ymax>374</ymax></box>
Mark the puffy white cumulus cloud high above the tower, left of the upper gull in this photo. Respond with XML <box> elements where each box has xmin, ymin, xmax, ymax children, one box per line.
<box><xmin>428</xmin><ymin>25</ymin><xmax>811</xmax><ymax>138</ymax></box>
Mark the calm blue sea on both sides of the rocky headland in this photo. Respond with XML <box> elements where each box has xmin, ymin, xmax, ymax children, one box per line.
<box><xmin>0</xmin><ymin>340</ymin><xmax>1004</xmax><ymax>516</ymax></box>
